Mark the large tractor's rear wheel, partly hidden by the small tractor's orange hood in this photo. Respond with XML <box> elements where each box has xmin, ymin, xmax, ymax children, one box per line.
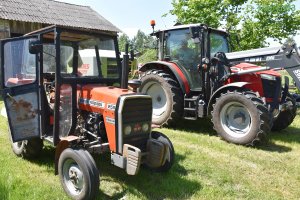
<box><xmin>139</xmin><ymin>70</ymin><xmax>183</xmax><ymax>126</ymax></box>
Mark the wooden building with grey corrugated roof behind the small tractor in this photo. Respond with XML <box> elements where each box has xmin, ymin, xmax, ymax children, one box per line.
<box><xmin>0</xmin><ymin>0</ymin><xmax>120</xmax><ymax>39</ymax></box>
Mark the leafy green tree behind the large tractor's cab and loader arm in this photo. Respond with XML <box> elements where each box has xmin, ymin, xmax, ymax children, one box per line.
<box><xmin>170</xmin><ymin>0</ymin><xmax>300</xmax><ymax>50</ymax></box>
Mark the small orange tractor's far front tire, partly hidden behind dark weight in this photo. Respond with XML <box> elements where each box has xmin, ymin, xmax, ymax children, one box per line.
<box><xmin>148</xmin><ymin>131</ymin><xmax>175</xmax><ymax>172</ymax></box>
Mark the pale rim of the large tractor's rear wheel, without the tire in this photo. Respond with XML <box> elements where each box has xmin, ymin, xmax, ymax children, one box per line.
<box><xmin>142</xmin><ymin>82</ymin><xmax>167</xmax><ymax>118</ymax></box>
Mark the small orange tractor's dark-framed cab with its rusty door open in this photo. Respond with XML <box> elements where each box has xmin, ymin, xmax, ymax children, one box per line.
<box><xmin>1</xmin><ymin>26</ymin><xmax>121</xmax><ymax>145</ymax></box>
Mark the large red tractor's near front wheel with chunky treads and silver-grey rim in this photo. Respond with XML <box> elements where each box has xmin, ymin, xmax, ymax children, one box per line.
<box><xmin>212</xmin><ymin>91</ymin><xmax>271</xmax><ymax>146</ymax></box>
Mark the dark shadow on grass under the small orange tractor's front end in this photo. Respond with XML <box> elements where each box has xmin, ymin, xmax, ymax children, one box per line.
<box><xmin>95</xmin><ymin>152</ymin><xmax>202</xmax><ymax>199</ymax></box>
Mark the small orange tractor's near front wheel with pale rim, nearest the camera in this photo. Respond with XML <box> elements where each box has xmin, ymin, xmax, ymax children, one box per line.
<box><xmin>58</xmin><ymin>148</ymin><xmax>99</xmax><ymax>200</ymax></box>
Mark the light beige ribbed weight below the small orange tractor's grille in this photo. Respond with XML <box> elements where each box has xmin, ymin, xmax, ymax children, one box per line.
<box><xmin>123</xmin><ymin>144</ymin><xmax>142</xmax><ymax>175</ymax></box>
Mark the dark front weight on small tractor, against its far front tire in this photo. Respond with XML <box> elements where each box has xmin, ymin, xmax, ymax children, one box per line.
<box><xmin>146</xmin><ymin>139</ymin><xmax>166</xmax><ymax>168</ymax></box>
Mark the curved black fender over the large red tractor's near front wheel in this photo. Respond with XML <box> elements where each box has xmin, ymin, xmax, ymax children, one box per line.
<box><xmin>207</xmin><ymin>82</ymin><xmax>250</xmax><ymax>116</ymax></box>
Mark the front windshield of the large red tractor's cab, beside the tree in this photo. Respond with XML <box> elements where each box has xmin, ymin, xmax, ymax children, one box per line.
<box><xmin>210</xmin><ymin>33</ymin><xmax>229</xmax><ymax>57</ymax></box>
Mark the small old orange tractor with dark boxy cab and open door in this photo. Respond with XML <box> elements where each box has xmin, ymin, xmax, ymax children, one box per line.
<box><xmin>0</xmin><ymin>26</ymin><xmax>174</xmax><ymax>199</ymax></box>
